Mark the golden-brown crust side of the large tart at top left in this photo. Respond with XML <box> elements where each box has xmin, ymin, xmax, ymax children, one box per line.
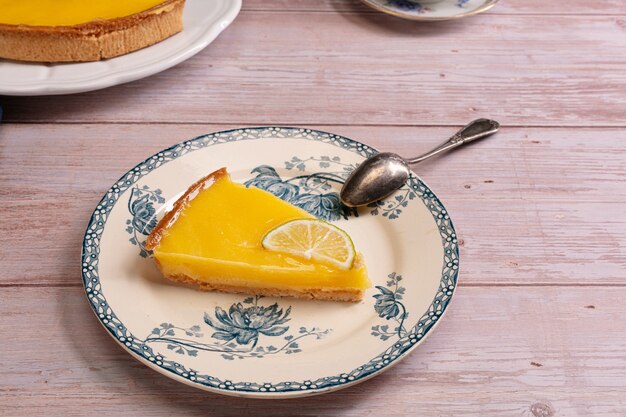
<box><xmin>0</xmin><ymin>0</ymin><xmax>185</xmax><ymax>62</ymax></box>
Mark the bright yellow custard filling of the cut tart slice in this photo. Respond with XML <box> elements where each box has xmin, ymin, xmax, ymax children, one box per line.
<box><xmin>153</xmin><ymin>172</ymin><xmax>370</xmax><ymax>290</ymax></box>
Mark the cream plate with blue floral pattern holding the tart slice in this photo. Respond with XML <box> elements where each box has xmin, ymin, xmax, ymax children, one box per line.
<box><xmin>82</xmin><ymin>127</ymin><xmax>459</xmax><ymax>398</ymax></box>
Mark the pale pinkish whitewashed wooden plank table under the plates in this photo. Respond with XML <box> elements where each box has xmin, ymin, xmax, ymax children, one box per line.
<box><xmin>0</xmin><ymin>0</ymin><xmax>626</xmax><ymax>417</ymax></box>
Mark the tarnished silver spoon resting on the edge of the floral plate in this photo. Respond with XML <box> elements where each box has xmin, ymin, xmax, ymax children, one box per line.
<box><xmin>340</xmin><ymin>119</ymin><xmax>500</xmax><ymax>207</ymax></box>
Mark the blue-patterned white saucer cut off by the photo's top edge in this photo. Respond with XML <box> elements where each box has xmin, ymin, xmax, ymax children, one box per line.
<box><xmin>362</xmin><ymin>0</ymin><xmax>498</xmax><ymax>21</ymax></box>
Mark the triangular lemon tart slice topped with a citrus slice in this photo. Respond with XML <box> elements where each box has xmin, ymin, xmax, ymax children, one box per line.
<box><xmin>146</xmin><ymin>168</ymin><xmax>370</xmax><ymax>301</ymax></box>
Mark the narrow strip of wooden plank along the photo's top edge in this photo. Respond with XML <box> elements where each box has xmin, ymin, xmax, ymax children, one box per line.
<box><xmin>242</xmin><ymin>0</ymin><xmax>626</xmax><ymax>16</ymax></box>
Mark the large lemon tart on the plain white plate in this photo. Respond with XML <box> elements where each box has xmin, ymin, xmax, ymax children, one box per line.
<box><xmin>0</xmin><ymin>0</ymin><xmax>185</xmax><ymax>62</ymax></box>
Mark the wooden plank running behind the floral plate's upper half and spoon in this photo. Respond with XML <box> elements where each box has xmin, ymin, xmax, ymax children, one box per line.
<box><xmin>0</xmin><ymin>125</ymin><xmax>626</xmax><ymax>285</ymax></box>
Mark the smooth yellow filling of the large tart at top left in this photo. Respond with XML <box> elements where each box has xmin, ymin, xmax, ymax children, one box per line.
<box><xmin>0</xmin><ymin>0</ymin><xmax>164</xmax><ymax>26</ymax></box>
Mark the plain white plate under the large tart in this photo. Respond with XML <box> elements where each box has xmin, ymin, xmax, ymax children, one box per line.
<box><xmin>0</xmin><ymin>0</ymin><xmax>241</xmax><ymax>96</ymax></box>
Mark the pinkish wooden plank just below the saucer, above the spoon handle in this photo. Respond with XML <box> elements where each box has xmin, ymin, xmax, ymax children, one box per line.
<box><xmin>2</xmin><ymin>12</ymin><xmax>626</xmax><ymax>126</ymax></box>
